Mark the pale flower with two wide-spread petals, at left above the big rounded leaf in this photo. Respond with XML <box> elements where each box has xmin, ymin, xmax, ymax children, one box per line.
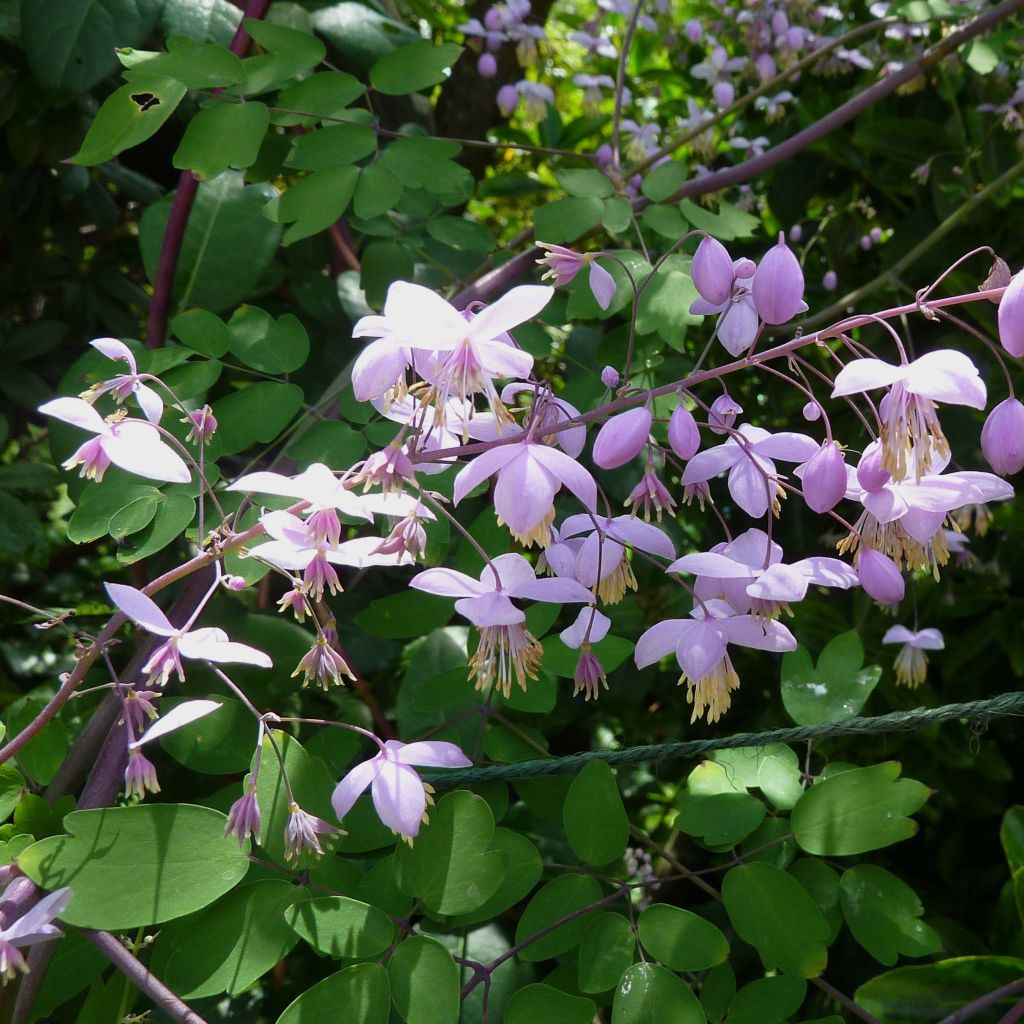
<box><xmin>103</xmin><ymin>583</ymin><xmax>273</xmax><ymax>687</ymax></box>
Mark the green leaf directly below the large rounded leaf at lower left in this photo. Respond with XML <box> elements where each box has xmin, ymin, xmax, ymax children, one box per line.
<box><xmin>154</xmin><ymin>879</ymin><xmax>308</xmax><ymax>999</ymax></box>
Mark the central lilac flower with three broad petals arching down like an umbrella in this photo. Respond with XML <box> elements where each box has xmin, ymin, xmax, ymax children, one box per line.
<box><xmin>455</xmin><ymin>438</ymin><xmax>597</xmax><ymax>547</ymax></box>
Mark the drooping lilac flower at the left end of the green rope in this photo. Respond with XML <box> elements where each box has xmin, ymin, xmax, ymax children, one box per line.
<box><xmin>331</xmin><ymin>739</ymin><xmax>473</xmax><ymax>840</ymax></box>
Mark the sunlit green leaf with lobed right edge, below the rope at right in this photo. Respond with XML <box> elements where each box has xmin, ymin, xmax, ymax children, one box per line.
<box><xmin>791</xmin><ymin>761</ymin><xmax>929</xmax><ymax>857</ymax></box>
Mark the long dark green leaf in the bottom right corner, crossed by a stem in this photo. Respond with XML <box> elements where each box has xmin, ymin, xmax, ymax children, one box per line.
<box><xmin>854</xmin><ymin>956</ymin><xmax>1024</xmax><ymax>1024</ymax></box>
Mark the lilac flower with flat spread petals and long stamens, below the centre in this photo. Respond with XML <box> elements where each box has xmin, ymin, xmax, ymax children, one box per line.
<box><xmin>410</xmin><ymin>553</ymin><xmax>593</xmax><ymax>696</ymax></box>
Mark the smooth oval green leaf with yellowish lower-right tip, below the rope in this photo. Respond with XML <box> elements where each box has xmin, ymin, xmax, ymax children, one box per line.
<box><xmin>722</xmin><ymin>863</ymin><xmax>829</xmax><ymax>978</ymax></box>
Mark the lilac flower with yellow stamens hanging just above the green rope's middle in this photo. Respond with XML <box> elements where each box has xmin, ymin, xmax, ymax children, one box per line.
<box><xmin>634</xmin><ymin>601</ymin><xmax>797</xmax><ymax>722</ymax></box>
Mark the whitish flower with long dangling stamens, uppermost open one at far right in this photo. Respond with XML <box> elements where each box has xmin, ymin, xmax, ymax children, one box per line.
<box><xmin>833</xmin><ymin>348</ymin><xmax>986</xmax><ymax>480</ymax></box>
